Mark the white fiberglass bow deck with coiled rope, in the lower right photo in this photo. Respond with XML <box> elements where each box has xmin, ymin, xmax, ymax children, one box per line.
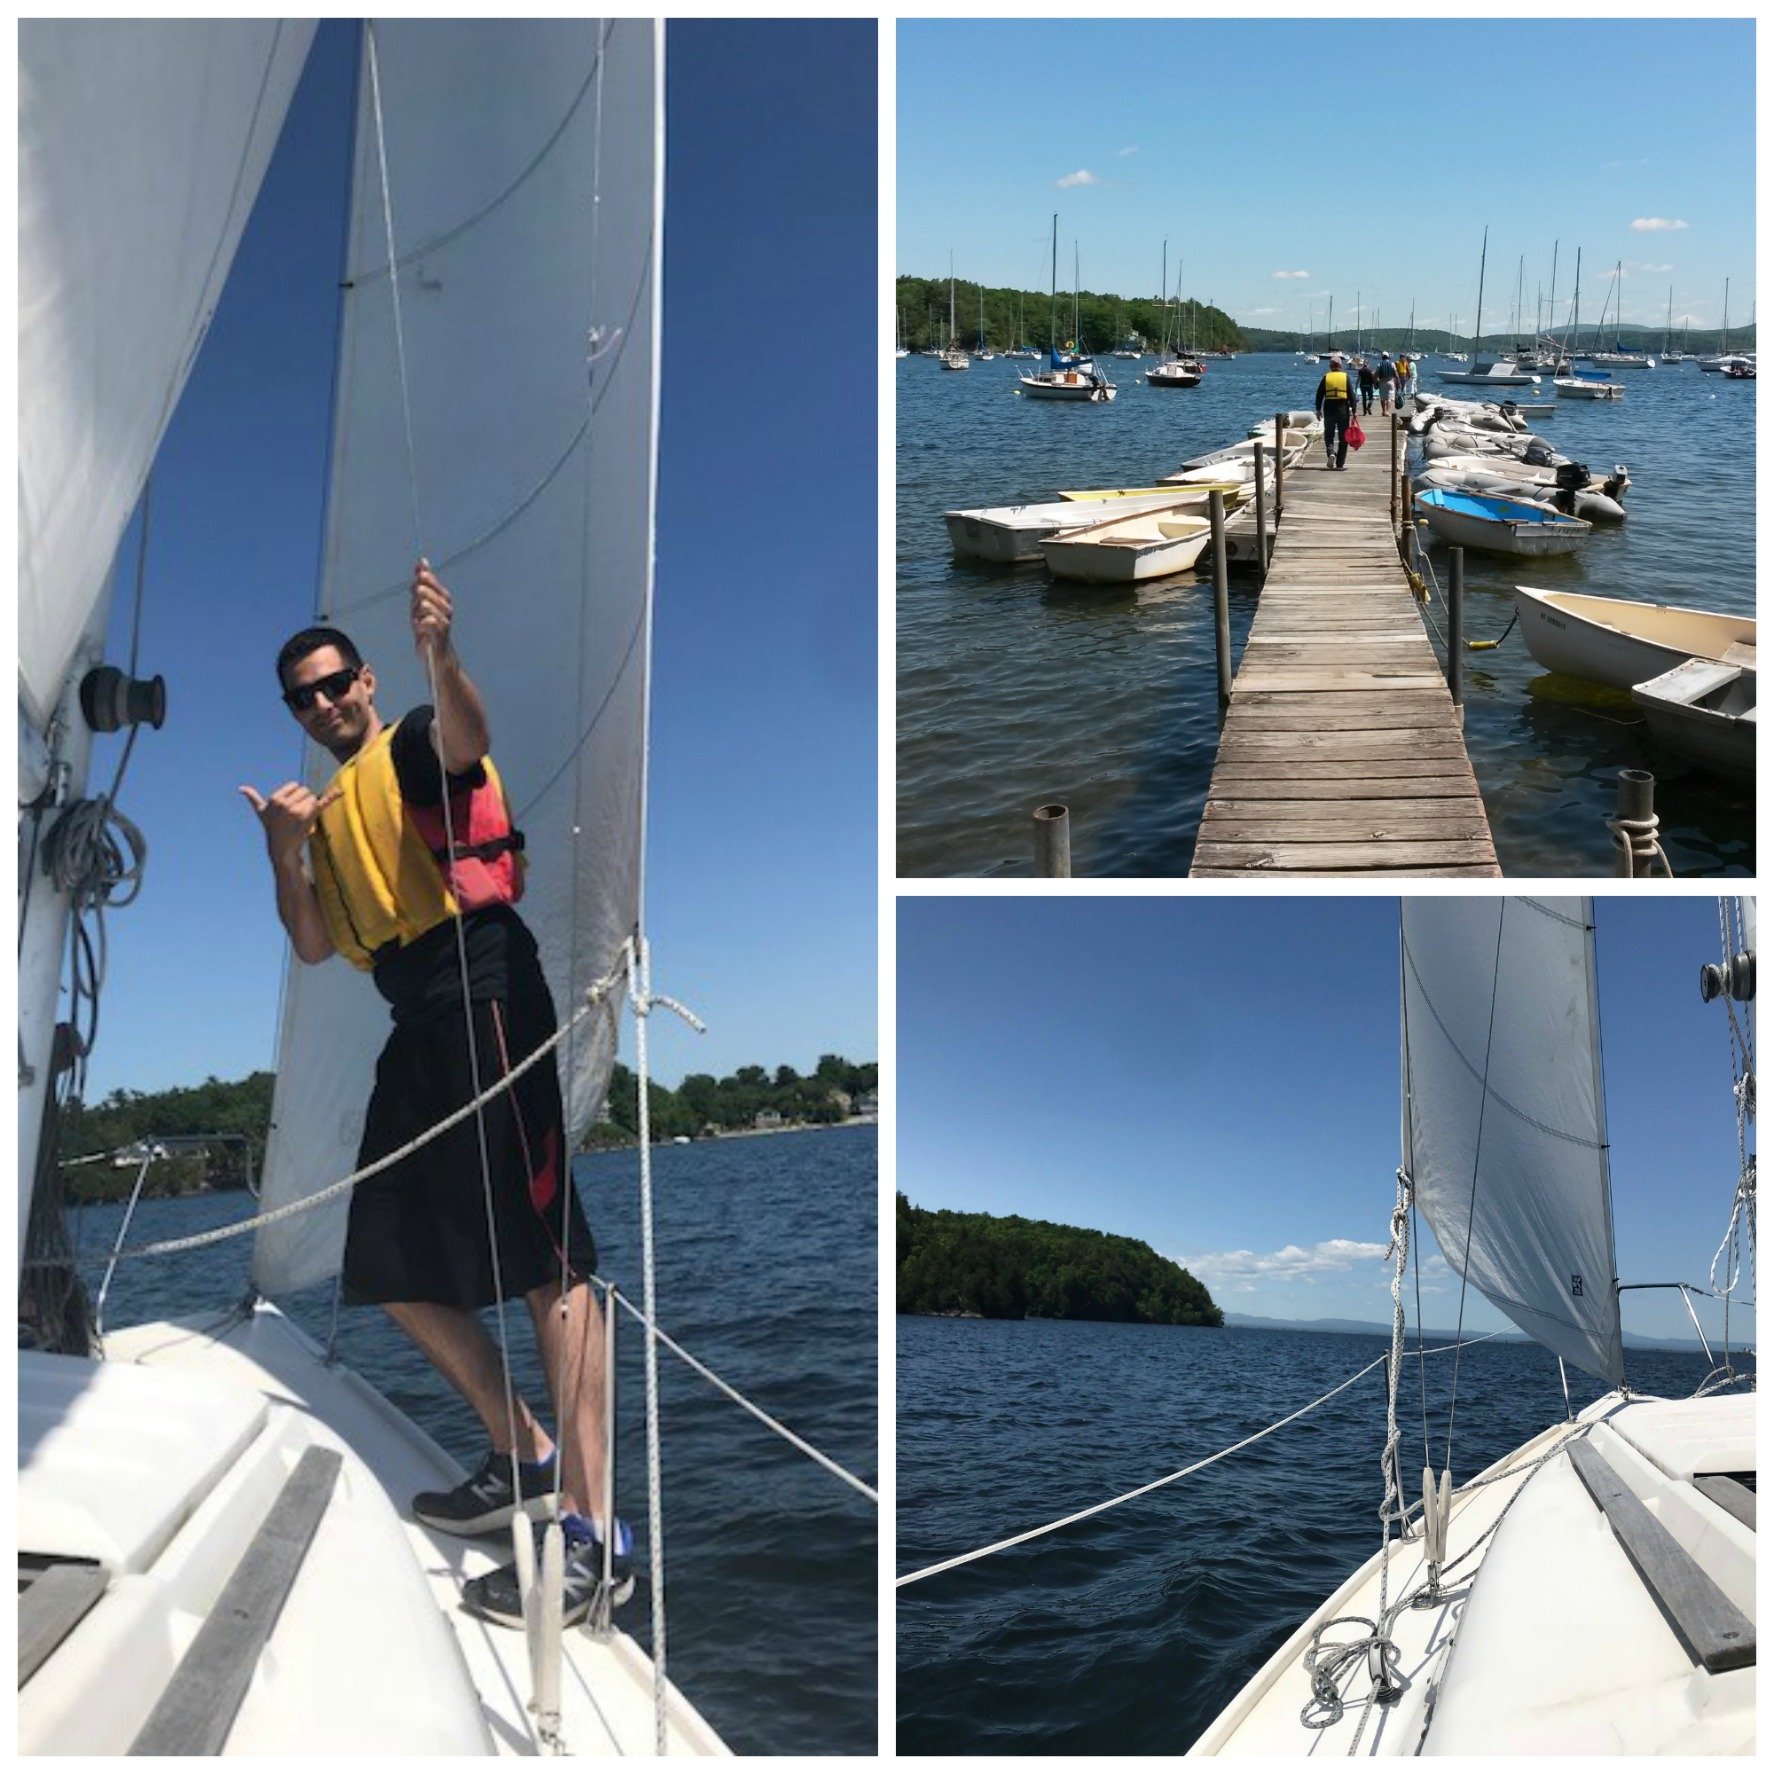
<box><xmin>1189</xmin><ymin>1394</ymin><xmax>1756</xmax><ymax>1758</ymax></box>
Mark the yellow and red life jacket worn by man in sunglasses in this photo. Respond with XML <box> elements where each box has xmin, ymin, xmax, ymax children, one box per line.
<box><xmin>309</xmin><ymin>724</ymin><xmax>523</xmax><ymax>972</ymax></box>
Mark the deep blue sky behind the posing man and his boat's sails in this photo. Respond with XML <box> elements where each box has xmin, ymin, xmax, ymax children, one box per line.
<box><xmin>89</xmin><ymin>20</ymin><xmax>876</xmax><ymax>1100</ymax></box>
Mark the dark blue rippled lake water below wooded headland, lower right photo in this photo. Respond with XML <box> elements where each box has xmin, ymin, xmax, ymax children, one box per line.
<box><xmin>896</xmin><ymin>1318</ymin><xmax>1745</xmax><ymax>1754</ymax></box>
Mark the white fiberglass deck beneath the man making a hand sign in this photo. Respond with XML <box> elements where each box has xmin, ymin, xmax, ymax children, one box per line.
<box><xmin>18</xmin><ymin>1306</ymin><xmax>726</xmax><ymax>1758</ymax></box>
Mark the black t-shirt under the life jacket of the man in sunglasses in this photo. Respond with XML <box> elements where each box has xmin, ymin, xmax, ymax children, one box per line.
<box><xmin>374</xmin><ymin>704</ymin><xmax>538</xmax><ymax>1022</ymax></box>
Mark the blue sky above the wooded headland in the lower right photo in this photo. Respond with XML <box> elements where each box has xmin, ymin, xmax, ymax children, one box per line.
<box><xmin>898</xmin><ymin>896</ymin><xmax>1737</xmax><ymax>1336</ymax></box>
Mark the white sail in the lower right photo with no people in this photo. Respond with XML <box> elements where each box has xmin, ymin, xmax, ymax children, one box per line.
<box><xmin>1401</xmin><ymin>896</ymin><xmax>1625</xmax><ymax>1385</ymax></box>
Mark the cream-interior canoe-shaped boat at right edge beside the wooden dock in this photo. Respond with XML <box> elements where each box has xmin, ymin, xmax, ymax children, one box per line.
<box><xmin>1515</xmin><ymin>585</ymin><xmax>1756</xmax><ymax>690</ymax></box>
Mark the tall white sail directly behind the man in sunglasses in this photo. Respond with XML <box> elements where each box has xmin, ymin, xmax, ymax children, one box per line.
<box><xmin>254</xmin><ymin>20</ymin><xmax>662</xmax><ymax>1293</ymax></box>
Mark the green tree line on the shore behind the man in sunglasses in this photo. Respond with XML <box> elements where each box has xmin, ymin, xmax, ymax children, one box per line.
<box><xmin>57</xmin><ymin>1054</ymin><xmax>878</xmax><ymax>1201</ymax></box>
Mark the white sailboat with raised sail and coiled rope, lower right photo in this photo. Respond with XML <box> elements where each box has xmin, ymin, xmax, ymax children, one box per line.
<box><xmin>1190</xmin><ymin>898</ymin><xmax>1756</xmax><ymax>1760</ymax></box>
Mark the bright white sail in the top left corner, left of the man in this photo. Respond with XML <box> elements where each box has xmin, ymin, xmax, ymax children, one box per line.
<box><xmin>18</xmin><ymin>20</ymin><xmax>314</xmax><ymax>733</ymax></box>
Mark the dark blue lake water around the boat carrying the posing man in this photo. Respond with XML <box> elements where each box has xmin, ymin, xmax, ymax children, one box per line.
<box><xmin>76</xmin><ymin>1126</ymin><xmax>878</xmax><ymax>1754</ymax></box>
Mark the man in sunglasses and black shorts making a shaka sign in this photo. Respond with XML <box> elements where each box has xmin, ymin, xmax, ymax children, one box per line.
<box><xmin>241</xmin><ymin>561</ymin><xmax>633</xmax><ymax>1625</ymax></box>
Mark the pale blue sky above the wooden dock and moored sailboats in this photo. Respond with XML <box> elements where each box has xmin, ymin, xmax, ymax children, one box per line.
<box><xmin>894</xmin><ymin>18</ymin><xmax>1754</xmax><ymax>337</ymax></box>
